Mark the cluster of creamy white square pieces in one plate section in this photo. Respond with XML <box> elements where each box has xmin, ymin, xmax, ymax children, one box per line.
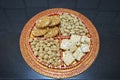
<box><xmin>60</xmin><ymin>35</ymin><xmax>90</xmax><ymax>65</ymax></box>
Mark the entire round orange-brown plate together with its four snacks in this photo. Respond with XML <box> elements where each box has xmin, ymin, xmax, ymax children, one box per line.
<box><xmin>20</xmin><ymin>8</ymin><xmax>99</xmax><ymax>78</ymax></box>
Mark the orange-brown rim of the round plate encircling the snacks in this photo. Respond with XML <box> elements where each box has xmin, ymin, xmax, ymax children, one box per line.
<box><xmin>20</xmin><ymin>8</ymin><xmax>99</xmax><ymax>78</ymax></box>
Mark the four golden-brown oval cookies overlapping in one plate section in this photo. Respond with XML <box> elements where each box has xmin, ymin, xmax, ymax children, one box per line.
<box><xmin>32</xmin><ymin>15</ymin><xmax>60</xmax><ymax>38</ymax></box>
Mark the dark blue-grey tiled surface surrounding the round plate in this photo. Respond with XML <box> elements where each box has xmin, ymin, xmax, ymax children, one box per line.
<box><xmin>0</xmin><ymin>0</ymin><xmax>120</xmax><ymax>80</ymax></box>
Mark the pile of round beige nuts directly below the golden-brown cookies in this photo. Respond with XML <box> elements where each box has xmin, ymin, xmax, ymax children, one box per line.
<box><xmin>29</xmin><ymin>38</ymin><xmax>61</xmax><ymax>67</ymax></box>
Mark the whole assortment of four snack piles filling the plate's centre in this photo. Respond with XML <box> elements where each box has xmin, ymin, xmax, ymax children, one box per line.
<box><xmin>29</xmin><ymin>13</ymin><xmax>91</xmax><ymax>68</ymax></box>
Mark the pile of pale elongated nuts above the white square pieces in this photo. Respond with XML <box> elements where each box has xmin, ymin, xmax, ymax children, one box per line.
<box><xmin>60</xmin><ymin>13</ymin><xmax>88</xmax><ymax>36</ymax></box>
